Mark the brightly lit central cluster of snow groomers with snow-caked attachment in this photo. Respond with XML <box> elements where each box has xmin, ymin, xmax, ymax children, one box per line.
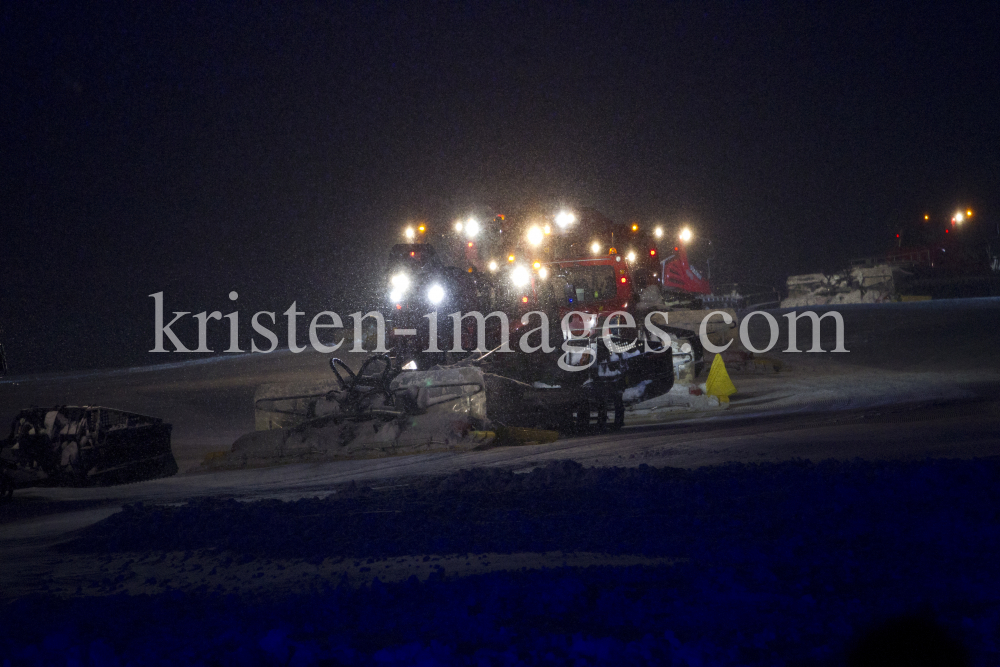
<box><xmin>242</xmin><ymin>209</ymin><xmax>740</xmax><ymax>465</ymax></box>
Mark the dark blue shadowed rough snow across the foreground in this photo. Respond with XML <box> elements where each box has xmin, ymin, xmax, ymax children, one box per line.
<box><xmin>0</xmin><ymin>459</ymin><xmax>1000</xmax><ymax>665</ymax></box>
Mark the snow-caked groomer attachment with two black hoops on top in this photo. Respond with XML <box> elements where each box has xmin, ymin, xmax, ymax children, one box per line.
<box><xmin>233</xmin><ymin>354</ymin><xmax>488</xmax><ymax>467</ymax></box>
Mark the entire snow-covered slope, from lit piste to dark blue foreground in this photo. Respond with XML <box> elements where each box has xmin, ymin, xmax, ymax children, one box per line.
<box><xmin>0</xmin><ymin>299</ymin><xmax>1000</xmax><ymax>665</ymax></box>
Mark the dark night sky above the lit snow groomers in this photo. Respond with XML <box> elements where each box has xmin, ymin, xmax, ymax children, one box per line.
<box><xmin>0</xmin><ymin>2</ymin><xmax>1000</xmax><ymax>371</ymax></box>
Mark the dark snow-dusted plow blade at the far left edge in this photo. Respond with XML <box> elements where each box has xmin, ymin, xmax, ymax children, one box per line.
<box><xmin>0</xmin><ymin>406</ymin><xmax>177</xmax><ymax>488</ymax></box>
